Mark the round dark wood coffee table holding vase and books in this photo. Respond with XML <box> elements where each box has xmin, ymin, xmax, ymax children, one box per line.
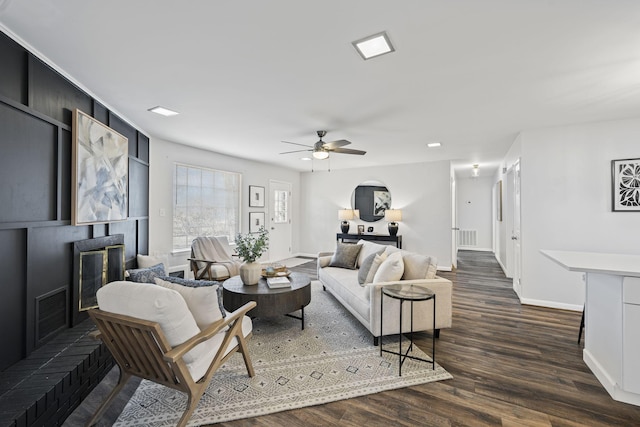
<box><xmin>222</xmin><ymin>273</ymin><xmax>311</xmax><ymax>329</ymax></box>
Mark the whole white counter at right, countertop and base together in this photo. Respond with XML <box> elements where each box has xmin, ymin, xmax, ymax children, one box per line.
<box><xmin>540</xmin><ymin>250</ymin><xmax>640</xmax><ymax>406</ymax></box>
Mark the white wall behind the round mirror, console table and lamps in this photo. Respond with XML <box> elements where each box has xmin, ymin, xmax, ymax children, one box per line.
<box><xmin>299</xmin><ymin>161</ymin><xmax>451</xmax><ymax>269</ymax></box>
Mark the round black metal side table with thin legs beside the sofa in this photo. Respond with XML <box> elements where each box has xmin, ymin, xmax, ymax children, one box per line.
<box><xmin>380</xmin><ymin>284</ymin><xmax>436</xmax><ymax>376</ymax></box>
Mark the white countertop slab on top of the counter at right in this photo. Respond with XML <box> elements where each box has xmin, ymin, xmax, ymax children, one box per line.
<box><xmin>540</xmin><ymin>249</ymin><xmax>640</xmax><ymax>277</ymax></box>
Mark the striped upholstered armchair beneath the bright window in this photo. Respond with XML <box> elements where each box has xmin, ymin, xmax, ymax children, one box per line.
<box><xmin>189</xmin><ymin>236</ymin><xmax>241</xmax><ymax>280</ymax></box>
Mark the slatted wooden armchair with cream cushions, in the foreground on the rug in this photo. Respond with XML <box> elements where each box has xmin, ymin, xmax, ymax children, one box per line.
<box><xmin>87</xmin><ymin>282</ymin><xmax>256</xmax><ymax>426</ymax></box>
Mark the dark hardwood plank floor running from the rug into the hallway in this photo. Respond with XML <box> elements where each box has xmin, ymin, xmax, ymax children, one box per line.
<box><xmin>70</xmin><ymin>251</ymin><xmax>640</xmax><ymax>427</ymax></box>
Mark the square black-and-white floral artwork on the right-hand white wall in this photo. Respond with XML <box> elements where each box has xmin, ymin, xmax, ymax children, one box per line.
<box><xmin>611</xmin><ymin>159</ymin><xmax>640</xmax><ymax>212</ymax></box>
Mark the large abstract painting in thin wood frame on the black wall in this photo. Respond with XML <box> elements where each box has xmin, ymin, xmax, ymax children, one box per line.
<box><xmin>71</xmin><ymin>109</ymin><xmax>129</xmax><ymax>225</ymax></box>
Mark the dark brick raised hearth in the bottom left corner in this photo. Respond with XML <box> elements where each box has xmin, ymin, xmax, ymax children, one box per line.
<box><xmin>0</xmin><ymin>320</ymin><xmax>114</xmax><ymax>427</ymax></box>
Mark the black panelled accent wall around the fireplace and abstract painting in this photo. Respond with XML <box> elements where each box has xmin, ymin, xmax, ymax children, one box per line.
<box><xmin>0</xmin><ymin>32</ymin><xmax>149</xmax><ymax>371</ymax></box>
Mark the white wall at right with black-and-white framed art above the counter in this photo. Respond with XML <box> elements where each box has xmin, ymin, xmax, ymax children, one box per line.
<box><xmin>508</xmin><ymin>119</ymin><xmax>640</xmax><ymax>309</ymax></box>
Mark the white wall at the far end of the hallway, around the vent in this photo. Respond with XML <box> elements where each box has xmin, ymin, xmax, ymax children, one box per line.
<box><xmin>456</xmin><ymin>177</ymin><xmax>494</xmax><ymax>251</ymax></box>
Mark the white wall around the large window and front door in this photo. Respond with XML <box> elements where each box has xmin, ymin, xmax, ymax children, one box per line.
<box><xmin>149</xmin><ymin>138</ymin><xmax>300</xmax><ymax>272</ymax></box>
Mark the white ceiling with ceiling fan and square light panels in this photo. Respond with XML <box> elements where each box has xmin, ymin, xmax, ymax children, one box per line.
<box><xmin>0</xmin><ymin>0</ymin><xmax>640</xmax><ymax>176</ymax></box>
